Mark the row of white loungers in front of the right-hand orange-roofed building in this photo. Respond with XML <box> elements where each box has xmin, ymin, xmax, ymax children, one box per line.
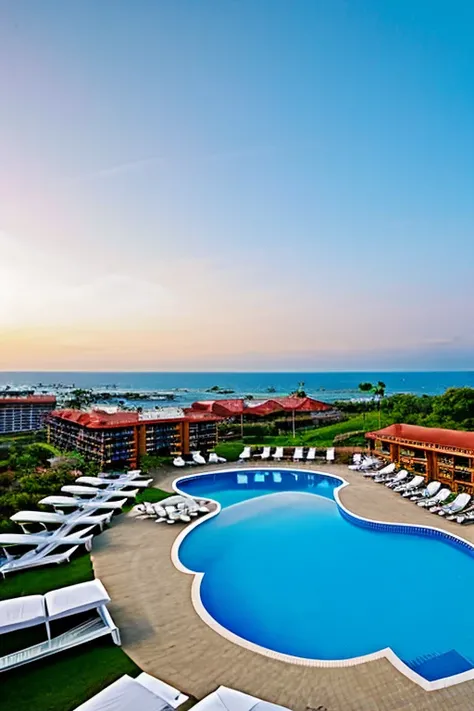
<box><xmin>350</xmin><ymin>458</ymin><xmax>474</xmax><ymax>524</ymax></box>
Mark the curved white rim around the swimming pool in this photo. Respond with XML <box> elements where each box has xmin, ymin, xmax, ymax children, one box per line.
<box><xmin>171</xmin><ymin>467</ymin><xmax>474</xmax><ymax>691</ymax></box>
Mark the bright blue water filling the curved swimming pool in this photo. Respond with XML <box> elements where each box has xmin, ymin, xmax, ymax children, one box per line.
<box><xmin>178</xmin><ymin>470</ymin><xmax>474</xmax><ymax>681</ymax></box>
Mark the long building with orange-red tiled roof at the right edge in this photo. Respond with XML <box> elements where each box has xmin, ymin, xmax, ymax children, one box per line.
<box><xmin>366</xmin><ymin>424</ymin><xmax>474</xmax><ymax>494</ymax></box>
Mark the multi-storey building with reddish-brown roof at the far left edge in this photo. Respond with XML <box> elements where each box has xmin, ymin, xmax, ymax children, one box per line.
<box><xmin>0</xmin><ymin>395</ymin><xmax>56</xmax><ymax>434</ymax></box>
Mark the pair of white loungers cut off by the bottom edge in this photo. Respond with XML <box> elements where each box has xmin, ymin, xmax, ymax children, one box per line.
<box><xmin>75</xmin><ymin>672</ymin><xmax>289</xmax><ymax>711</ymax></box>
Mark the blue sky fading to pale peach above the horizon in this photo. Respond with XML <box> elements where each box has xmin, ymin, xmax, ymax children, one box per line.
<box><xmin>0</xmin><ymin>0</ymin><xmax>474</xmax><ymax>371</ymax></box>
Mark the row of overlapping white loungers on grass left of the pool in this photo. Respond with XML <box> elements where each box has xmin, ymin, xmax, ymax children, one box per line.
<box><xmin>0</xmin><ymin>470</ymin><xmax>152</xmax><ymax>578</ymax></box>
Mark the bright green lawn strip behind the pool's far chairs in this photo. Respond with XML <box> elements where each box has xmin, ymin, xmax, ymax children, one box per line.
<box><xmin>216</xmin><ymin>412</ymin><xmax>391</xmax><ymax>461</ymax></box>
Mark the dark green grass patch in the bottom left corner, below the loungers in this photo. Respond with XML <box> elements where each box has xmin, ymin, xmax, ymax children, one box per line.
<box><xmin>0</xmin><ymin>639</ymin><xmax>140</xmax><ymax>711</ymax></box>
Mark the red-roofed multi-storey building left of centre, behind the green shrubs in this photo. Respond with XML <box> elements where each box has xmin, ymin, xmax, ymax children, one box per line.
<box><xmin>47</xmin><ymin>407</ymin><xmax>222</xmax><ymax>468</ymax></box>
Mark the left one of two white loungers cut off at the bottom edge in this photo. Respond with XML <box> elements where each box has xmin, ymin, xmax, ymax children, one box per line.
<box><xmin>76</xmin><ymin>674</ymin><xmax>174</xmax><ymax>711</ymax></box>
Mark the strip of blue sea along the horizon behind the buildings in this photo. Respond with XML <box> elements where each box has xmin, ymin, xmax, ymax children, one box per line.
<box><xmin>0</xmin><ymin>371</ymin><xmax>474</xmax><ymax>404</ymax></box>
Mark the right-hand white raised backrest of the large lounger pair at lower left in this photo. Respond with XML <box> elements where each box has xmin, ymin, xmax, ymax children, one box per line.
<box><xmin>44</xmin><ymin>580</ymin><xmax>110</xmax><ymax>620</ymax></box>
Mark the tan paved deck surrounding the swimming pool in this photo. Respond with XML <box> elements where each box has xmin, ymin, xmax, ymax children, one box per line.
<box><xmin>92</xmin><ymin>462</ymin><xmax>474</xmax><ymax>711</ymax></box>
